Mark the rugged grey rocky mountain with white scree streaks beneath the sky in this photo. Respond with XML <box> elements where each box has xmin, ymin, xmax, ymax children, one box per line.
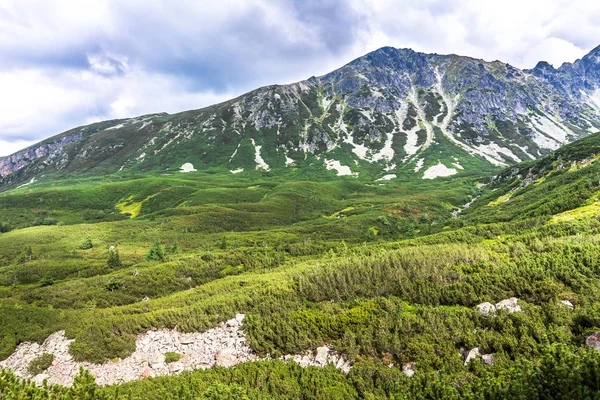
<box><xmin>0</xmin><ymin>47</ymin><xmax>600</xmax><ymax>187</ymax></box>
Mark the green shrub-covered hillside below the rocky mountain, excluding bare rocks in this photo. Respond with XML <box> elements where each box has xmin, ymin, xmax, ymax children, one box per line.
<box><xmin>5</xmin><ymin>134</ymin><xmax>600</xmax><ymax>399</ymax></box>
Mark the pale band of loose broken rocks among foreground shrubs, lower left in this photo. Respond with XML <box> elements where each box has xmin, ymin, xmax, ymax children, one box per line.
<box><xmin>0</xmin><ymin>314</ymin><xmax>351</xmax><ymax>386</ymax></box>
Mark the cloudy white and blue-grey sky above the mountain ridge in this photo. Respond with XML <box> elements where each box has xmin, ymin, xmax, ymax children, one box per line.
<box><xmin>0</xmin><ymin>0</ymin><xmax>600</xmax><ymax>156</ymax></box>
